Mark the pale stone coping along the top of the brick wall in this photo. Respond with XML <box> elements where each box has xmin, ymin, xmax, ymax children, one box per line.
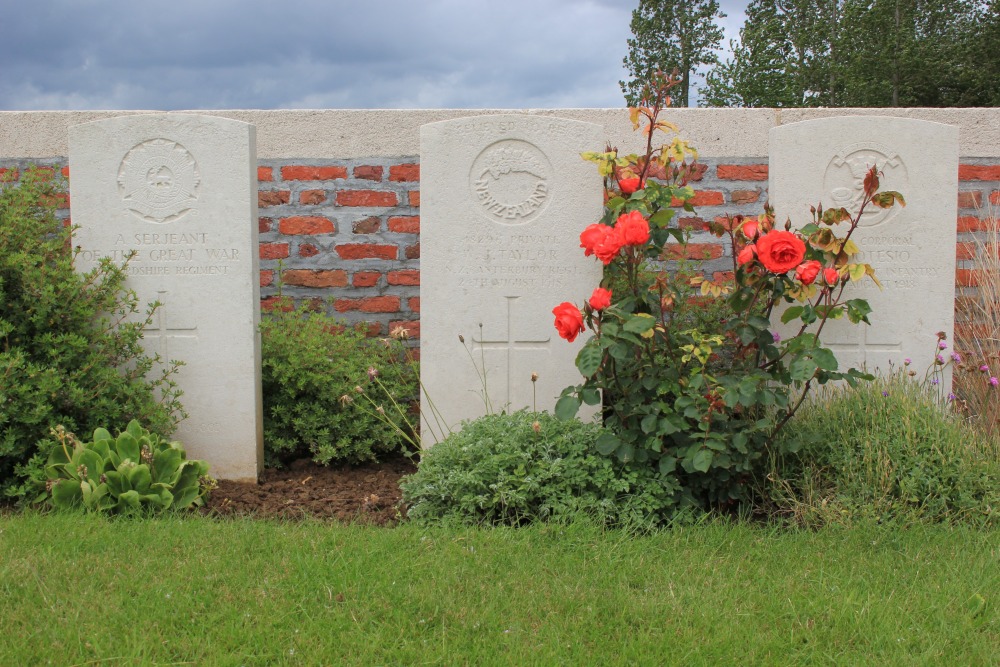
<box><xmin>0</xmin><ymin>108</ymin><xmax>1000</xmax><ymax>160</ymax></box>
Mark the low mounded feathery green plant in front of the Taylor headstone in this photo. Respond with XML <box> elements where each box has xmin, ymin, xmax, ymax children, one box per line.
<box><xmin>400</xmin><ymin>410</ymin><xmax>678</xmax><ymax>525</ymax></box>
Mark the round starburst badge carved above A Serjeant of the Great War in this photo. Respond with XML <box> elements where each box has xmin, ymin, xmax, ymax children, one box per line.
<box><xmin>118</xmin><ymin>139</ymin><xmax>201</xmax><ymax>224</ymax></box>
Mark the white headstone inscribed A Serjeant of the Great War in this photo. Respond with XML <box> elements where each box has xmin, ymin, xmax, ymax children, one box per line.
<box><xmin>69</xmin><ymin>113</ymin><xmax>263</xmax><ymax>479</ymax></box>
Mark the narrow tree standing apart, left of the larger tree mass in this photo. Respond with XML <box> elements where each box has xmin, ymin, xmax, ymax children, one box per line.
<box><xmin>619</xmin><ymin>0</ymin><xmax>726</xmax><ymax>107</ymax></box>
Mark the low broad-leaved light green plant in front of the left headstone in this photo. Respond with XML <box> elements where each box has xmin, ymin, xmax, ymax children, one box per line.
<box><xmin>34</xmin><ymin>420</ymin><xmax>215</xmax><ymax>514</ymax></box>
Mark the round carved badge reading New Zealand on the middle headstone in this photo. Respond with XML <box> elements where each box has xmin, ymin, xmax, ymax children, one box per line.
<box><xmin>469</xmin><ymin>139</ymin><xmax>552</xmax><ymax>225</ymax></box>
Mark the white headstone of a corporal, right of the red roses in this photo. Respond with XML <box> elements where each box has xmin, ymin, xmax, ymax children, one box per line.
<box><xmin>769</xmin><ymin>116</ymin><xmax>958</xmax><ymax>384</ymax></box>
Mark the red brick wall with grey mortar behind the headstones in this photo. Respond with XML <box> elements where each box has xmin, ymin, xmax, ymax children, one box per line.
<box><xmin>0</xmin><ymin>157</ymin><xmax>1000</xmax><ymax>344</ymax></box>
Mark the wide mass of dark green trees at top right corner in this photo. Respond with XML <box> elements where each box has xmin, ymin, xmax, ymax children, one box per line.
<box><xmin>704</xmin><ymin>0</ymin><xmax>1000</xmax><ymax>107</ymax></box>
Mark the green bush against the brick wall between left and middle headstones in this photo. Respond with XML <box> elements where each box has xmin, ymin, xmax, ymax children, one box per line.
<box><xmin>260</xmin><ymin>297</ymin><xmax>417</xmax><ymax>466</ymax></box>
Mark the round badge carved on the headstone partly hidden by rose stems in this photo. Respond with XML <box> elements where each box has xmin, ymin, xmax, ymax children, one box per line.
<box><xmin>823</xmin><ymin>142</ymin><xmax>908</xmax><ymax>227</ymax></box>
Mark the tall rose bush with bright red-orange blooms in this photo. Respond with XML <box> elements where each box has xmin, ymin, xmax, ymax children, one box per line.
<box><xmin>553</xmin><ymin>72</ymin><xmax>903</xmax><ymax>508</ymax></box>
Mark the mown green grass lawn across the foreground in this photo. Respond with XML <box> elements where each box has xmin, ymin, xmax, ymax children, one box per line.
<box><xmin>0</xmin><ymin>514</ymin><xmax>1000</xmax><ymax>665</ymax></box>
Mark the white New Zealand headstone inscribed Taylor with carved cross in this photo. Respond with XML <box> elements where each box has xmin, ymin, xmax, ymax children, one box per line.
<box><xmin>420</xmin><ymin>114</ymin><xmax>604</xmax><ymax>446</ymax></box>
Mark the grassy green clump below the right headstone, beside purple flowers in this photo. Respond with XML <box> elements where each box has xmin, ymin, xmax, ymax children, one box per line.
<box><xmin>768</xmin><ymin>370</ymin><xmax>1000</xmax><ymax>523</ymax></box>
